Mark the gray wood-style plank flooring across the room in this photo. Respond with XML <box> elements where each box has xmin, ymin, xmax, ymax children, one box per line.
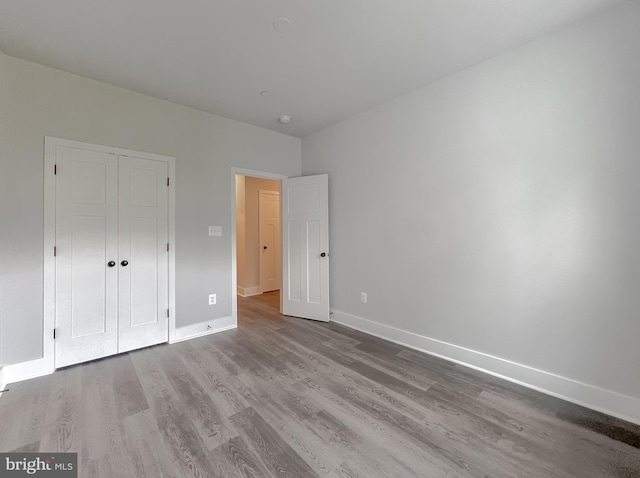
<box><xmin>0</xmin><ymin>293</ymin><xmax>640</xmax><ymax>478</ymax></box>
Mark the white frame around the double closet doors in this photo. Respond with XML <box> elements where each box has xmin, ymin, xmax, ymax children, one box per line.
<box><xmin>42</xmin><ymin>136</ymin><xmax>176</xmax><ymax>371</ymax></box>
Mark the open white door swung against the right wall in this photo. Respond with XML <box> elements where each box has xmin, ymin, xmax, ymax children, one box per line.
<box><xmin>282</xmin><ymin>174</ymin><xmax>329</xmax><ymax>322</ymax></box>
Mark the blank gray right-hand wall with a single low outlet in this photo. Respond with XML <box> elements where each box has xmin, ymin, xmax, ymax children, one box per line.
<box><xmin>302</xmin><ymin>2</ymin><xmax>640</xmax><ymax>397</ymax></box>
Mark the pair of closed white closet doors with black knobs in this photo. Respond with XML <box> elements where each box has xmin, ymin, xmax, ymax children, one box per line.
<box><xmin>55</xmin><ymin>147</ymin><xmax>168</xmax><ymax>367</ymax></box>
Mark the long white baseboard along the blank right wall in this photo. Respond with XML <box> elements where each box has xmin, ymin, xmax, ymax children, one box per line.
<box><xmin>331</xmin><ymin>310</ymin><xmax>640</xmax><ymax>425</ymax></box>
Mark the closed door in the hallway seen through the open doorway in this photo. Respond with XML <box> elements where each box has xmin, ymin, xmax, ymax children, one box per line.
<box><xmin>258</xmin><ymin>189</ymin><xmax>282</xmax><ymax>292</ymax></box>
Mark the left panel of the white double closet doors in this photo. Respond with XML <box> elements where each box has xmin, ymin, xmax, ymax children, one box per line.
<box><xmin>55</xmin><ymin>147</ymin><xmax>118</xmax><ymax>367</ymax></box>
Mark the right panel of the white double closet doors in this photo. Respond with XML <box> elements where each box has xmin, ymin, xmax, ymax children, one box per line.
<box><xmin>118</xmin><ymin>156</ymin><xmax>169</xmax><ymax>353</ymax></box>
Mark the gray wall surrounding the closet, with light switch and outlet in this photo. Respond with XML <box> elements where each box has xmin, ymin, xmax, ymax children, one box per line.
<box><xmin>0</xmin><ymin>54</ymin><xmax>300</xmax><ymax>363</ymax></box>
